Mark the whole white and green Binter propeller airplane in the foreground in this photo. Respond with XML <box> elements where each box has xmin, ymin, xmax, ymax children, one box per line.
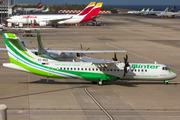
<box><xmin>3</xmin><ymin>33</ymin><xmax>177</xmax><ymax>85</ymax></box>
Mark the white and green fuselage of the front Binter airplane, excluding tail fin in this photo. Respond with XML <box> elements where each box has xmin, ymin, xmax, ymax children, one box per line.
<box><xmin>3</xmin><ymin>61</ymin><xmax>177</xmax><ymax>81</ymax></box>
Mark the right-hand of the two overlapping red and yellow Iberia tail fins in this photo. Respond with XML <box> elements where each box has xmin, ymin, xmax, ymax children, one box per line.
<box><xmin>80</xmin><ymin>3</ymin><xmax>103</xmax><ymax>22</ymax></box>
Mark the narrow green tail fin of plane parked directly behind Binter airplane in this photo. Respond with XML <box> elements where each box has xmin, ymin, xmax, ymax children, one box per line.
<box><xmin>37</xmin><ymin>30</ymin><xmax>46</xmax><ymax>55</ymax></box>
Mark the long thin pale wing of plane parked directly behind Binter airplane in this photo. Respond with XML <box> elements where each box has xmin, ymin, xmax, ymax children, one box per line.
<box><xmin>47</xmin><ymin>50</ymin><xmax>127</xmax><ymax>55</ymax></box>
